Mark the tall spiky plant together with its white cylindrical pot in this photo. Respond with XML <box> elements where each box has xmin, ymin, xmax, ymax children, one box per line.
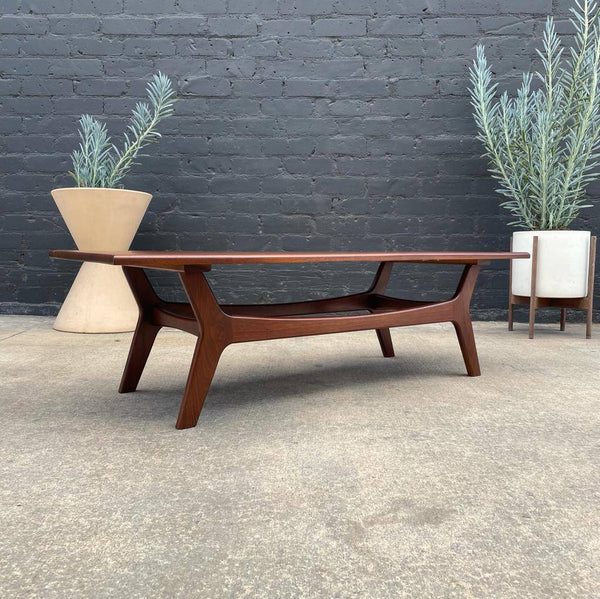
<box><xmin>469</xmin><ymin>0</ymin><xmax>600</xmax><ymax>298</ymax></box>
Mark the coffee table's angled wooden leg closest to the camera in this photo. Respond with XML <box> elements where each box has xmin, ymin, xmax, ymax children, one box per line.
<box><xmin>175</xmin><ymin>268</ymin><xmax>230</xmax><ymax>429</ymax></box>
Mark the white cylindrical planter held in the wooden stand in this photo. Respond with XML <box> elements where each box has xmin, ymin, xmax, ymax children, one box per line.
<box><xmin>512</xmin><ymin>231</ymin><xmax>590</xmax><ymax>298</ymax></box>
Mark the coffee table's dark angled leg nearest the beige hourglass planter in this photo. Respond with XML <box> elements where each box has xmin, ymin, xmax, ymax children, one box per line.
<box><xmin>119</xmin><ymin>266</ymin><xmax>161</xmax><ymax>393</ymax></box>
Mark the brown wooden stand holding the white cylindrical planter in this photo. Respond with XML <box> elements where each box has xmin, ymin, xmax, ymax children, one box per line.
<box><xmin>508</xmin><ymin>236</ymin><xmax>596</xmax><ymax>339</ymax></box>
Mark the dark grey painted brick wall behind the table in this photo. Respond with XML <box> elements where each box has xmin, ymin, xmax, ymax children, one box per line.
<box><xmin>0</xmin><ymin>0</ymin><xmax>600</xmax><ymax>318</ymax></box>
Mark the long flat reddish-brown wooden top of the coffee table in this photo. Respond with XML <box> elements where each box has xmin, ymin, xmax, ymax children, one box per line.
<box><xmin>50</xmin><ymin>250</ymin><xmax>529</xmax><ymax>270</ymax></box>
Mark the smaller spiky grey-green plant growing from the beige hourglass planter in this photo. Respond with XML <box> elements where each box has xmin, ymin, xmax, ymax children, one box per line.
<box><xmin>69</xmin><ymin>73</ymin><xmax>176</xmax><ymax>187</ymax></box>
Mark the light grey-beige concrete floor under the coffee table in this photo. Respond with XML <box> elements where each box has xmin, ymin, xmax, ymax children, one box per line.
<box><xmin>0</xmin><ymin>316</ymin><xmax>600</xmax><ymax>599</ymax></box>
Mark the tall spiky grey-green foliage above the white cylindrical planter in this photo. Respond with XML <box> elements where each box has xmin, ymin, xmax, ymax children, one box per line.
<box><xmin>469</xmin><ymin>0</ymin><xmax>600</xmax><ymax>230</ymax></box>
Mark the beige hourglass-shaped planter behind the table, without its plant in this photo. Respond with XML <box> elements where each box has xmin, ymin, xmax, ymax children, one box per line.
<box><xmin>52</xmin><ymin>187</ymin><xmax>152</xmax><ymax>333</ymax></box>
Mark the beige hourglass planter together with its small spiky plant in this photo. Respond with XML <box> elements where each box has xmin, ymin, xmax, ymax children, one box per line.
<box><xmin>52</xmin><ymin>73</ymin><xmax>175</xmax><ymax>333</ymax></box>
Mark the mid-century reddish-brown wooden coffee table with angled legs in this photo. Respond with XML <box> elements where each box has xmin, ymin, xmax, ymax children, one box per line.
<box><xmin>50</xmin><ymin>250</ymin><xmax>529</xmax><ymax>429</ymax></box>
